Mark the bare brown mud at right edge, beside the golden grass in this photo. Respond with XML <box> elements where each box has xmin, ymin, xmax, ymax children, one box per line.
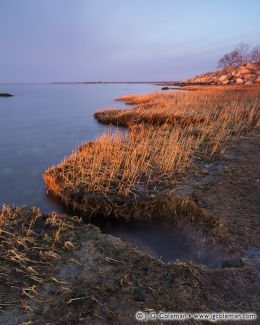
<box><xmin>176</xmin><ymin>133</ymin><xmax>260</xmax><ymax>248</ymax></box>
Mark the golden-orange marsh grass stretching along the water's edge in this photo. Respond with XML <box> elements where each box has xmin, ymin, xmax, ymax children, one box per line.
<box><xmin>44</xmin><ymin>86</ymin><xmax>260</xmax><ymax>214</ymax></box>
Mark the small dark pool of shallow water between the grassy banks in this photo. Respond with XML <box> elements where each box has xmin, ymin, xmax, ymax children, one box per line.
<box><xmin>96</xmin><ymin>220</ymin><xmax>223</xmax><ymax>268</ymax></box>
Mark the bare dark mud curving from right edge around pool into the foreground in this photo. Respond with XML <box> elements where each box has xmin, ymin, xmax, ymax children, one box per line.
<box><xmin>0</xmin><ymin>135</ymin><xmax>260</xmax><ymax>325</ymax></box>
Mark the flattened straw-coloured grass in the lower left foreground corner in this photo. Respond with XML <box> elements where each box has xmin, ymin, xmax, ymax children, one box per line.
<box><xmin>0</xmin><ymin>205</ymin><xmax>78</xmax><ymax>311</ymax></box>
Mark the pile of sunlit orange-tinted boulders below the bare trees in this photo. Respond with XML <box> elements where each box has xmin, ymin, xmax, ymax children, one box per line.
<box><xmin>185</xmin><ymin>63</ymin><xmax>260</xmax><ymax>85</ymax></box>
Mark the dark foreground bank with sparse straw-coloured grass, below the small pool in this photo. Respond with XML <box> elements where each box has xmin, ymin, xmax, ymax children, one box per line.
<box><xmin>0</xmin><ymin>206</ymin><xmax>259</xmax><ymax>325</ymax></box>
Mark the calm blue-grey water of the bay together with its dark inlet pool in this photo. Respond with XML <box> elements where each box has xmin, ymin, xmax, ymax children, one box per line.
<box><xmin>0</xmin><ymin>84</ymin><xmax>221</xmax><ymax>263</ymax></box>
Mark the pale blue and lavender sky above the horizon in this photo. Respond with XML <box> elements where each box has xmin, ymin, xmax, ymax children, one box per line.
<box><xmin>0</xmin><ymin>0</ymin><xmax>260</xmax><ymax>82</ymax></box>
